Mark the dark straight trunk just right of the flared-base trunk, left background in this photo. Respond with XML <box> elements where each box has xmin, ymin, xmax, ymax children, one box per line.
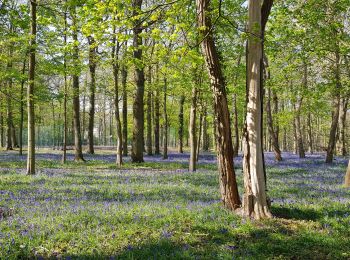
<box><xmin>87</xmin><ymin>36</ymin><xmax>97</xmax><ymax>154</ymax></box>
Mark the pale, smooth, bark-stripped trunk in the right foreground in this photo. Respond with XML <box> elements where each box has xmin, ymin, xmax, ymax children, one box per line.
<box><xmin>243</xmin><ymin>0</ymin><xmax>272</xmax><ymax>219</ymax></box>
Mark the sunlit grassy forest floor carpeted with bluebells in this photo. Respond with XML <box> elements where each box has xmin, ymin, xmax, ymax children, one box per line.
<box><xmin>0</xmin><ymin>149</ymin><xmax>350</xmax><ymax>259</ymax></box>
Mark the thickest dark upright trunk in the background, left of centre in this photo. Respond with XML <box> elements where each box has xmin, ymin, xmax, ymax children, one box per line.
<box><xmin>131</xmin><ymin>0</ymin><xmax>145</xmax><ymax>163</ymax></box>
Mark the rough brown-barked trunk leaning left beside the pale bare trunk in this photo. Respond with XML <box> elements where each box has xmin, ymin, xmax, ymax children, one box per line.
<box><xmin>196</xmin><ymin>0</ymin><xmax>241</xmax><ymax>210</ymax></box>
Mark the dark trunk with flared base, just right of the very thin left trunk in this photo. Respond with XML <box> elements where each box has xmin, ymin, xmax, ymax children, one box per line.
<box><xmin>72</xmin><ymin>7</ymin><xmax>85</xmax><ymax>161</ymax></box>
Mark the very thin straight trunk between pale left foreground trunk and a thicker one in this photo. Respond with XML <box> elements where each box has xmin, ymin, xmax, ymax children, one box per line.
<box><xmin>62</xmin><ymin>6</ymin><xmax>68</xmax><ymax>164</ymax></box>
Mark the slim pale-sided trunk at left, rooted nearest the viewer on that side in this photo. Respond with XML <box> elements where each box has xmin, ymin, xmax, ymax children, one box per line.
<box><xmin>27</xmin><ymin>0</ymin><xmax>37</xmax><ymax>174</ymax></box>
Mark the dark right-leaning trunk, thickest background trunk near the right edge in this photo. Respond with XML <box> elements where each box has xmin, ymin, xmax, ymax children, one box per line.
<box><xmin>326</xmin><ymin>49</ymin><xmax>341</xmax><ymax>163</ymax></box>
